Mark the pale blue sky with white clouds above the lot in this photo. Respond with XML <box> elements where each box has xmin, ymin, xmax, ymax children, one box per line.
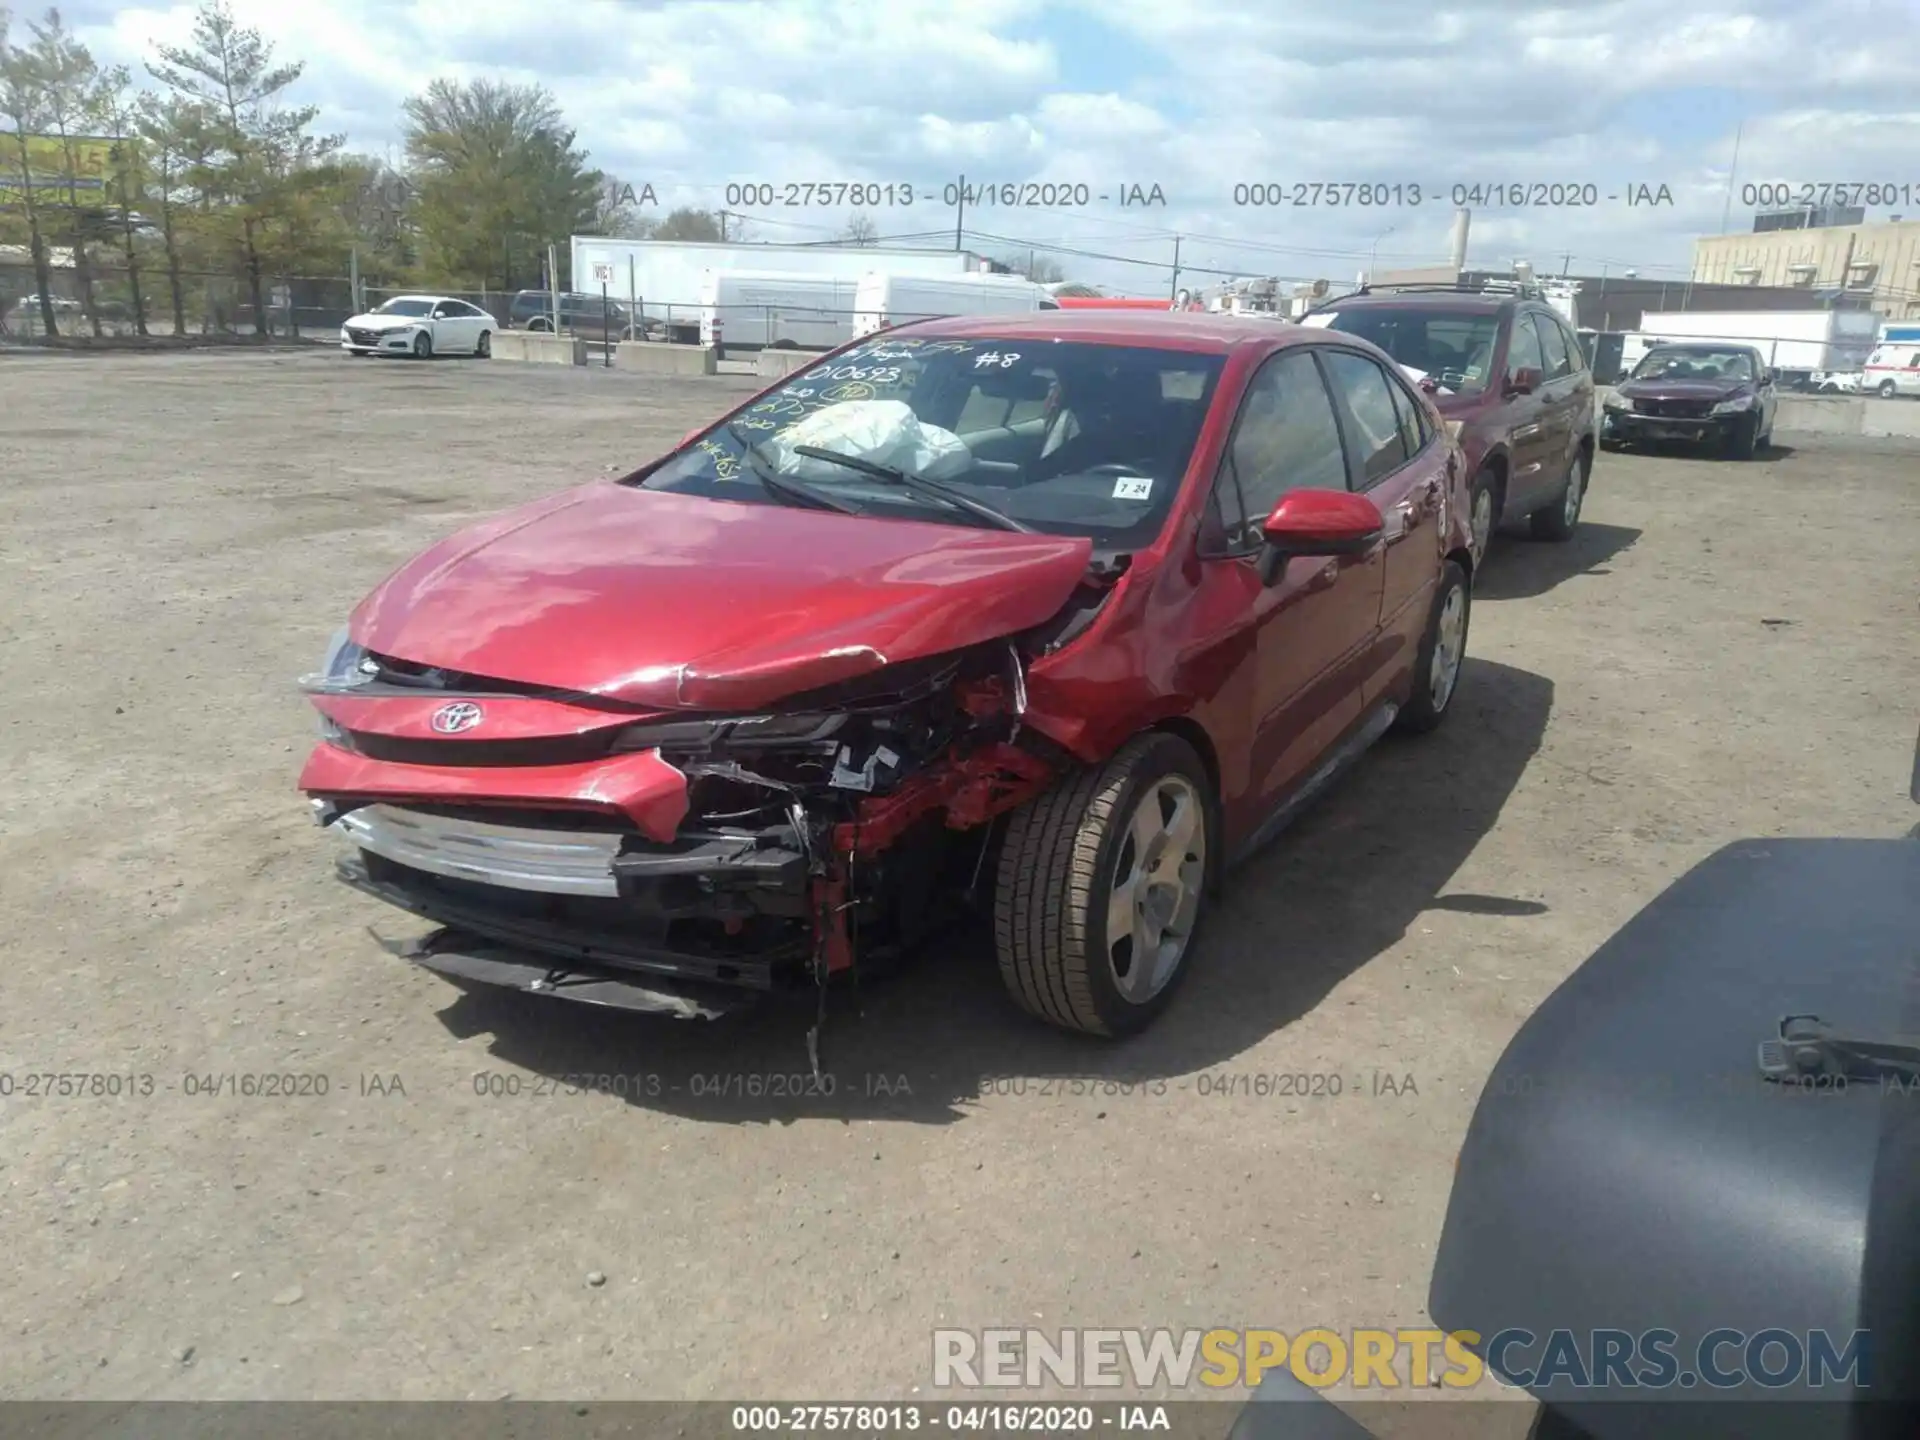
<box><xmin>52</xmin><ymin>0</ymin><xmax>1920</xmax><ymax>294</ymax></box>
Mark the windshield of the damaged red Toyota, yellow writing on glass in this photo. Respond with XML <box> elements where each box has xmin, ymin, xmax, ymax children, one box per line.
<box><xmin>637</xmin><ymin>336</ymin><xmax>1223</xmax><ymax>551</ymax></box>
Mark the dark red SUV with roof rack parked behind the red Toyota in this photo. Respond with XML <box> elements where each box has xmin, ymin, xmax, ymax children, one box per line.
<box><xmin>1302</xmin><ymin>286</ymin><xmax>1597</xmax><ymax>559</ymax></box>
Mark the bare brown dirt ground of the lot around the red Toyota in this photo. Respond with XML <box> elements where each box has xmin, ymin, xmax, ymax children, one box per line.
<box><xmin>0</xmin><ymin>353</ymin><xmax>1920</xmax><ymax>1400</ymax></box>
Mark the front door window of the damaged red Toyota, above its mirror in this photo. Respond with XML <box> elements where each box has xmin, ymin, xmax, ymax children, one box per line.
<box><xmin>1215</xmin><ymin>349</ymin><xmax>1351</xmax><ymax>547</ymax></box>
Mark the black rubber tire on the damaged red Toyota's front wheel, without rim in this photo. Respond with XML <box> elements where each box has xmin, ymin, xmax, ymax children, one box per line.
<box><xmin>993</xmin><ymin>733</ymin><xmax>1219</xmax><ymax>1037</ymax></box>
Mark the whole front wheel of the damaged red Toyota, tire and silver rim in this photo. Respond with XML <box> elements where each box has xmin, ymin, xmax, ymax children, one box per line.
<box><xmin>993</xmin><ymin>733</ymin><xmax>1219</xmax><ymax>1037</ymax></box>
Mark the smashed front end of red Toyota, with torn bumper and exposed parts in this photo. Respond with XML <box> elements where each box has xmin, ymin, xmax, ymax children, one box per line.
<box><xmin>301</xmin><ymin>639</ymin><xmax>1058</xmax><ymax>1016</ymax></box>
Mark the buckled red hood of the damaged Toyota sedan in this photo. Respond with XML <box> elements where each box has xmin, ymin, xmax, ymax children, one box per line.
<box><xmin>348</xmin><ymin>482</ymin><xmax>1092</xmax><ymax>710</ymax></box>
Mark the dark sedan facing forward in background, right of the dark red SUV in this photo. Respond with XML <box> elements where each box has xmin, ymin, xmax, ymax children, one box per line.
<box><xmin>1599</xmin><ymin>344</ymin><xmax>1780</xmax><ymax>459</ymax></box>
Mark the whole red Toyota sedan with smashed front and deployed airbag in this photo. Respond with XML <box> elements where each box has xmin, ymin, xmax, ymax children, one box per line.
<box><xmin>300</xmin><ymin>313</ymin><xmax>1473</xmax><ymax>1035</ymax></box>
